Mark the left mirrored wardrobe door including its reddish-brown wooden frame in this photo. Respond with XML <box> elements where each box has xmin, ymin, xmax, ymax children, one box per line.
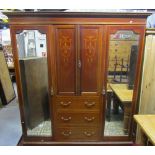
<box><xmin>12</xmin><ymin>26</ymin><xmax>52</xmax><ymax>139</ymax></box>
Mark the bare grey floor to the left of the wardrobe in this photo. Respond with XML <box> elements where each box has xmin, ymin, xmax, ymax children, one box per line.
<box><xmin>0</xmin><ymin>84</ymin><xmax>22</xmax><ymax>146</ymax></box>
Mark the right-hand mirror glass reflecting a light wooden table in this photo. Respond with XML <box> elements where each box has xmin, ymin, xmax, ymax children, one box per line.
<box><xmin>104</xmin><ymin>30</ymin><xmax>139</xmax><ymax>136</ymax></box>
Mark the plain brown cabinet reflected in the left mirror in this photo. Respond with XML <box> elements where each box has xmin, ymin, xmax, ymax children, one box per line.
<box><xmin>19</xmin><ymin>57</ymin><xmax>49</xmax><ymax>128</ymax></box>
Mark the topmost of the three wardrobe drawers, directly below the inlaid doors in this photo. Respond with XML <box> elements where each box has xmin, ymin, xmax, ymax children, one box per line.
<box><xmin>55</xmin><ymin>96</ymin><xmax>100</xmax><ymax>110</ymax></box>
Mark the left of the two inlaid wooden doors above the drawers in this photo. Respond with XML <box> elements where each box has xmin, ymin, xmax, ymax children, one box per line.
<box><xmin>55</xmin><ymin>25</ymin><xmax>76</xmax><ymax>95</ymax></box>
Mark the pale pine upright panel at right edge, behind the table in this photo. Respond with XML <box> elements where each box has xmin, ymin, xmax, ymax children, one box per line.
<box><xmin>139</xmin><ymin>34</ymin><xmax>155</xmax><ymax>114</ymax></box>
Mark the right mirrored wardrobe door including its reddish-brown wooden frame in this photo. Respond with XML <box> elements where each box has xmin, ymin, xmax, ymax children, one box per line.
<box><xmin>104</xmin><ymin>25</ymin><xmax>144</xmax><ymax>140</ymax></box>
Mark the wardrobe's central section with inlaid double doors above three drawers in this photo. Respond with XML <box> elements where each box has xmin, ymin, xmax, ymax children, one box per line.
<box><xmin>51</xmin><ymin>25</ymin><xmax>105</xmax><ymax>141</ymax></box>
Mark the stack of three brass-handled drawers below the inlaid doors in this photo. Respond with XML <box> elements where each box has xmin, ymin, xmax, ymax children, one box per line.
<box><xmin>53</xmin><ymin>96</ymin><xmax>102</xmax><ymax>141</ymax></box>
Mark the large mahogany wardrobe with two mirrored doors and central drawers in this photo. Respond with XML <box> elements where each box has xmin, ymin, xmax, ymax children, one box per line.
<box><xmin>6</xmin><ymin>12</ymin><xmax>149</xmax><ymax>145</ymax></box>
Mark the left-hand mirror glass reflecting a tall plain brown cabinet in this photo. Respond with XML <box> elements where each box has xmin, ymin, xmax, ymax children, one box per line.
<box><xmin>16</xmin><ymin>30</ymin><xmax>52</xmax><ymax>136</ymax></box>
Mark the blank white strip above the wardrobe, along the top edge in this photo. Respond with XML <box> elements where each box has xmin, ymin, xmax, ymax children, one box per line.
<box><xmin>0</xmin><ymin>0</ymin><xmax>155</xmax><ymax>9</ymax></box>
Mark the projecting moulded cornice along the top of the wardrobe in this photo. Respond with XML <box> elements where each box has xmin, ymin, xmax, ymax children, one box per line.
<box><xmin>5</xmin><ymin>12</ymin><xmax>151</xmax><ymax>25</ymax></box>
